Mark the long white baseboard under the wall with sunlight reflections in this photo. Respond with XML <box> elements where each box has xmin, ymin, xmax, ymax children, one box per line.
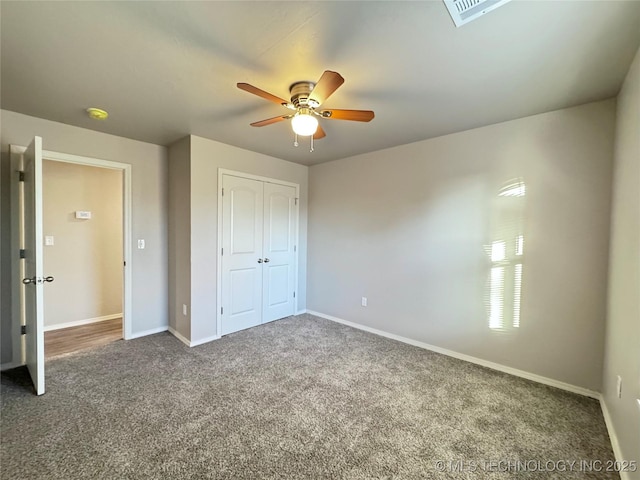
<box><xmin>307</xmin><ymin>310</ymin><xmax>600</xmax><ymax>400</ymax></box>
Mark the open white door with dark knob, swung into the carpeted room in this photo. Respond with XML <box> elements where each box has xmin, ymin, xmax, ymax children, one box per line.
<box><xmin>21</xmin><ymin>137</ymin><xmax>46</xmax><ymax>395</ymax></box>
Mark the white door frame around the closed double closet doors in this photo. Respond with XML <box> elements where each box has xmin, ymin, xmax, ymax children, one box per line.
<box><xmin>216</xmin><ymin>168</ymin><xmax>300</xmax><ymax>337</ymax></box>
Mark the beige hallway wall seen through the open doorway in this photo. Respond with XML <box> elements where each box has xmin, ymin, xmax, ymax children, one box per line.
<box><xmin>42</xmin><ymin>160</ymin><xmax>124</xmax><ymax>328</ymax></box>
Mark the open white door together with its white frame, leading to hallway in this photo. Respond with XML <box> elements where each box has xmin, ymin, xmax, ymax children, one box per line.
<box><xmin>9</xmin><ymin>141</ymin><xmax>133</xmax><ymax>395</ymax></box>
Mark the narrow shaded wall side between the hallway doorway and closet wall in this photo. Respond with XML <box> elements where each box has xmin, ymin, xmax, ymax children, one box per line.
<box><xmin>169</xmin><ymin>137</ymin><xmax>191</xmax><ymax>339</ymax></box>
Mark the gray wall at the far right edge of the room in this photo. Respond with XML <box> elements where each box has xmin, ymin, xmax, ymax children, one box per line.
<box><xmin>602</xmin><ymin>50</ymin><xmax>640</xmax><ymax>479</ymax></box>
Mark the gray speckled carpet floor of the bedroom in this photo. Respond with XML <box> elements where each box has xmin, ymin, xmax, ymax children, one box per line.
<box><xmin>0</xmin><ymin>315</ymin><xmax>619</xmax><ymax>480</ymax></box>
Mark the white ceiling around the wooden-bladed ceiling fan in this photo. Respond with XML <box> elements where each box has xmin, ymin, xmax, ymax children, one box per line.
<box><xmin>0</xmin><ymin>1</ymin><xmax>640</xmax><ymax>165</ymax></box>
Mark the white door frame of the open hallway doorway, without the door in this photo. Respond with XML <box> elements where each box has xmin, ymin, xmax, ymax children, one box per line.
<box><xmin>10</xmin><ymin>145</ymin><xmax>133</xmax><ymax>342</ymax></box>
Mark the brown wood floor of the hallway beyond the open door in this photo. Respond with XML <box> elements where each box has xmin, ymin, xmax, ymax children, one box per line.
<box><xmin>44</xmin><ymin>318</ymin><xmax>122</xmax><ymax>358</ymax></box>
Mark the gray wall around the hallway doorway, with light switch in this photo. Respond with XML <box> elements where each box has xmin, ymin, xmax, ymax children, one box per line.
<box><xmin>1</xmin><ymin>110</ymin><xmax>168</xmax><ymax>362</ymax></box>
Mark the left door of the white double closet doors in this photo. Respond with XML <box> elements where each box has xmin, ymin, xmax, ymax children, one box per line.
<box><xmin>220</xmin><ymin>175</ymin><xmax>264</xmax><ymax>335</ymax></box>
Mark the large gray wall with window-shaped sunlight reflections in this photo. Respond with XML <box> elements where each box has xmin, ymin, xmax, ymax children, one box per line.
<box><xmin>307</xmin><ymin>100</ymin><xmax>615</xmax><ymax>390</ymax></box>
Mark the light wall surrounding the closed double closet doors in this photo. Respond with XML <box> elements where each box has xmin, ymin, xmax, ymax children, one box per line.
<box><xmin>166</xmin><ymin>136</ymin><xmax>308</xmax><ymax>343</ymax></box>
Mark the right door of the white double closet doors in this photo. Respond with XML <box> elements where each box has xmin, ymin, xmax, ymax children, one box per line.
<box><xmin>262</xmin><ymin>183</ymin><xmax>296</xmax><ymax>323</ymax></box>
